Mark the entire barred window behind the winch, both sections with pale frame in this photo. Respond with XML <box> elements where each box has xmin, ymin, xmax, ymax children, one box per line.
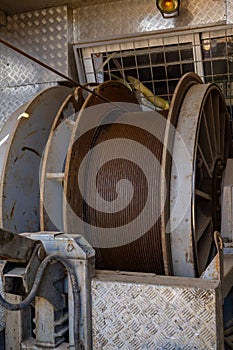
<box><xmin>74</xmin><ymin>26</ymin><xmax>233</xmax><ymax>117</ymax></box>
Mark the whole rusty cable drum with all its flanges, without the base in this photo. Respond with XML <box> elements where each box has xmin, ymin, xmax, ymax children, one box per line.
<box><xmin>0</xmin><ymin>73</ymin><xmax>231</xmax><ymax>276</ymax></box>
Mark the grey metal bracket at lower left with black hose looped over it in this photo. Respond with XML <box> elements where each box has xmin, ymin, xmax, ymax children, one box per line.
<box><xmin>4</xmin><ymin>232</ymin><xmax>95</xmax><ymax>350</ymax></box>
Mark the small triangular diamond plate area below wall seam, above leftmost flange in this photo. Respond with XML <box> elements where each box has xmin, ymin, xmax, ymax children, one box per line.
<box><xmin>0</xmin><ymin>83</ymin><xmax>55</xmax><ymax>129</ymax></box>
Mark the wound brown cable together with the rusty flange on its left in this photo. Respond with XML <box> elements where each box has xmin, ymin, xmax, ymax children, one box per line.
<box><xmin>64</xmin><ymin>82</ymin><xmax>166</xmax><ymax>273</ymax></box>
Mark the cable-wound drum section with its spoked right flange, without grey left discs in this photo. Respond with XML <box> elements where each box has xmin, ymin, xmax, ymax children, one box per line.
<box><xmin>60</xmin><ymin>73</ymin><xmax>233</xmax><ymax>276</ymax></box>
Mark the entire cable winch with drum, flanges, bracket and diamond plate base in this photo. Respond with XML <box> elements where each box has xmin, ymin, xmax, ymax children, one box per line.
<box><xmin>0</xmin><ymin>69</ymin><xmax>233</xmax><ymax>350</ymax></box>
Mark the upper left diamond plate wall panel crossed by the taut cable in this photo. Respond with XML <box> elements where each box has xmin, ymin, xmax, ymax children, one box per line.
<box><xmin>0</xmin><ymin>6</ymin><xmax>72</xmax><ymax>86</ymax></box>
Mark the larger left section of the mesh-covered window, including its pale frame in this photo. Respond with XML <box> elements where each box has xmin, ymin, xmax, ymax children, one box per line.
<box><xmin>76</xmin><ymin>35</ymin><xmax>195</xmax><ymax>108</ymax></box>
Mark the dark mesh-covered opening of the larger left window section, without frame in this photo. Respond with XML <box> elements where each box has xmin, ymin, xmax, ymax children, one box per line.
<box><xmin>92</xmin><ymin>43</ymin><xmax>194</xmax><ymax>101</ymax></box>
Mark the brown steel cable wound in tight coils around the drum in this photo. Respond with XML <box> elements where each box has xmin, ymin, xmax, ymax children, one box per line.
<box><xmin>67</xmin><ymin>112</ymin><xmax>167</xmax><ymax>274</ymax></box>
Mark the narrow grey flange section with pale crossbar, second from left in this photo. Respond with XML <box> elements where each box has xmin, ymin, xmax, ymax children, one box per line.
<box><xmin>40</xmin><ymin>94</ymin><xmax>78</xmax><ymax>231</ymax></box>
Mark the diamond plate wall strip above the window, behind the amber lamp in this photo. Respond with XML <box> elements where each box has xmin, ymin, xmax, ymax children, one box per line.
<box><xmin>74</xmin><ymin>0</ymin><xmax>226</xmax><ymax>42</ymax></box>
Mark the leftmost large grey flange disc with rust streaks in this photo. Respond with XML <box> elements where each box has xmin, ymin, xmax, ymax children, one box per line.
<box><xmin>0</xmin><ymin>86</ymin><xmax>71</xmax><ymax>233</ymax></box>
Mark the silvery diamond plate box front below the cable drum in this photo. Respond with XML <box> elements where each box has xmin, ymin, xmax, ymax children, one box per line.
<box><xmin>92</xmin><ymin>278</ymin><xmax>223</xmax><ymax>350</ymax></box>
